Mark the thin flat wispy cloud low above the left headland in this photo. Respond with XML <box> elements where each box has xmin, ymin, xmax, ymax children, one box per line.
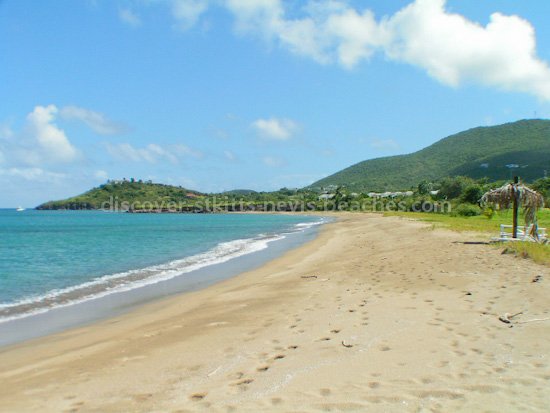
<box><xmin>107</xmin><ymin>143</ymin><xmax>202</xmax><ymax>164</ymax></box>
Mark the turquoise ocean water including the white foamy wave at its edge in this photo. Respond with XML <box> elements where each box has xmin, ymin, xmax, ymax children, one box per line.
<box><xmin>0</xmin><ymin>210</ymin><xmax>324</xmax><ymax>323</ymax></box>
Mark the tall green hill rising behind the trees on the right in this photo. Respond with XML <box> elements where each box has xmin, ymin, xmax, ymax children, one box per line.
<box><xmin>310</xmin><ymin>120</ymin><xmax>550</xmax><ymax>191</ymax></box>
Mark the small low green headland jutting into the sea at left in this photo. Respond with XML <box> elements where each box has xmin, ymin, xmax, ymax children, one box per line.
<box><xmin>37</xmin><ymin>180</ymin><xmax>202</xmax><ymax>209</ymax></box>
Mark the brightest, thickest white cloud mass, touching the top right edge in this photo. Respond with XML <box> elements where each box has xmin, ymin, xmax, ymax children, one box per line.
<box><xmin>381</xmin><ymin>0</ymin><xmax>550</xmax><ymax>100</ymax></box>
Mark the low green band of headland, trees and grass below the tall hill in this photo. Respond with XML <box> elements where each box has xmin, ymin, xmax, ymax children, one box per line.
<box><xmin>38</xmin><ymin>176</ymin><xmax>550</xmax><ymax>263</ymax></box>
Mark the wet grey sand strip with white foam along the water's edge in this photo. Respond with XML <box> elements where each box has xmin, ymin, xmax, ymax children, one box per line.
<box><xmin>0</xmin><ymin>214</ymin><xmax>332</xmax><ymax>349</ymax></box>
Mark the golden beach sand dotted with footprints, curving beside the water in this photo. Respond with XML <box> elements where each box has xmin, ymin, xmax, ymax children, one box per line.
<box><xmin>0</xmin><ymin>214</ymin><xmax>550</xmax><ymax>412</ymax></box>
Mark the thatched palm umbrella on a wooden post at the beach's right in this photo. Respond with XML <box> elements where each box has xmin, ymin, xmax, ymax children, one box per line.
<box><xmin>481</xmin><ymin>177</ymin><xmax>544</xmax><ymax>238</ymax></box>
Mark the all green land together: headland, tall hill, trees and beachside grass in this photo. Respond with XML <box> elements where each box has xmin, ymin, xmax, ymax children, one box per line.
<box><xmin>34</xmin><ymin>116</ymin><xmax>550</xmax><ymax>263</ymax></box>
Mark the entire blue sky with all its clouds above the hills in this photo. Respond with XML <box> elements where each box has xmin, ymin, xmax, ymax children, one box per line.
<box><xmin>0</xmin><ymin>0</ymin><xmax>550</xmax><ymax>207</ymax></box>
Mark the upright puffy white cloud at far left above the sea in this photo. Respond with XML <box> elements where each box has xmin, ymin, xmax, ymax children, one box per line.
<box><xmin>27</xmin><ymin>105</ymin><xmax>80</xmax><ymax>163</ymax></box>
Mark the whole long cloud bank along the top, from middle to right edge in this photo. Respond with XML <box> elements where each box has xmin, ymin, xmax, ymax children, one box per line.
<box><xmin>225</xmin><ymin>0</ymin><xmax>550</xmax><ymax>100</ymax></box>
